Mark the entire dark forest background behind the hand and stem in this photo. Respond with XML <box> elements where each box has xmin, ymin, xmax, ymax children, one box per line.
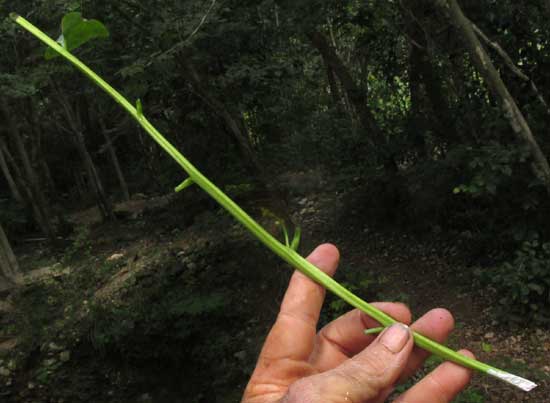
<box><xmin>0</xmin><ymin>0</ymin><xmax>550</xmax><ymax>403</ymax></box>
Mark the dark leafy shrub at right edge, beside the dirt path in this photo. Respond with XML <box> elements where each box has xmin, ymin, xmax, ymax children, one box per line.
<box><xmin>480</xmin><ymin>237</ymin><xmax>550</xmax><ymax>324</ymax></box>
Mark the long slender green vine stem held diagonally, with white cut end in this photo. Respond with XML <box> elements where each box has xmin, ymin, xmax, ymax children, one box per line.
<box><xmin>10</xmin><ymin>13</ymin><xmax>537</xmax><ymax>391</ymax></box>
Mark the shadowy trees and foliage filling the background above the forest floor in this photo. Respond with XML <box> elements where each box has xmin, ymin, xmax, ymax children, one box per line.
<box><xmin>0</xmin><ymin>0</ymin><xmax>550</xmax><ymax>321</ymax></box>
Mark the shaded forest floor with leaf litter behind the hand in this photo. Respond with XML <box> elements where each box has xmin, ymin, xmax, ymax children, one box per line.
<box><xmin>0</xmin><ymin>175</ymin><xmax>550</xmax><ymax>403</ymax></box>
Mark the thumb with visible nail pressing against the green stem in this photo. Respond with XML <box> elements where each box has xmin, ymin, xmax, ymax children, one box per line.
<box><xmin>283</xmin><ymin>324</ymin><xmax>414</xmax><ymax>403</ymax></box>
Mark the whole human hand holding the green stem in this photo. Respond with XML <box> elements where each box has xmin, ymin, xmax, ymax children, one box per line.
<box><xmin>241</xmin><ymin>244</ymin><xmax>472</xmax><ymax>403</ymax></box>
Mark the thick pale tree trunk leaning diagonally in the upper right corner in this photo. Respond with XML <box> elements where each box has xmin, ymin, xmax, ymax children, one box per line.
<box><xmin>442</xmin><ymin>0</ymin><xmax>550</xmax><ymax>195</ymax></box>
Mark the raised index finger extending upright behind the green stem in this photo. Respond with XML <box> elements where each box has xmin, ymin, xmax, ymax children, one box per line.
<box><xmin>258</xmin><ymin>244</ymin><xmax>340</xmax><ymax>366</ymax></box>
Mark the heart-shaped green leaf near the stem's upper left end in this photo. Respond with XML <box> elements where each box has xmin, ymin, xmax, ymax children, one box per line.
<box><xmin>45</xmin><ymin>12</ymin><xmax>109</xmax><ymax>59</ymax></box>
